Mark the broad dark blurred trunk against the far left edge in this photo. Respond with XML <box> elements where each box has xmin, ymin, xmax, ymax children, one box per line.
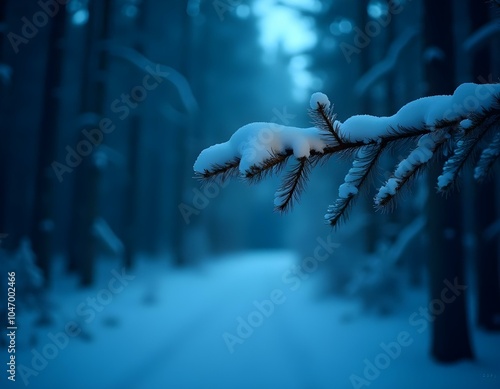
<box><xmin>0</xmin><ymin>0</ymin><xmax>52</xmax><ymax>250</ymax></box>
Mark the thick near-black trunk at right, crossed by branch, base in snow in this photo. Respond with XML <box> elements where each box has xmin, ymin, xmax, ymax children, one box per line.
<box><xmin>424</xmin><ymin>0</ymin><xmax>473</xmax><ymax>362</ymax></box>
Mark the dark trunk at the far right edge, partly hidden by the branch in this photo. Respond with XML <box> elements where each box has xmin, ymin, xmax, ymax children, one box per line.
<box><xmin>469</xmin><ymin>0</ymin><xmax>500</xmax><ymax>330</ymax></box>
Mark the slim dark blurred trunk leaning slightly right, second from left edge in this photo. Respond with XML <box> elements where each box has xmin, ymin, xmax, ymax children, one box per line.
<box><xmin>31</xmin><ymin>5</ymin><xmax>66</xmax><ymax>283</ymax></box>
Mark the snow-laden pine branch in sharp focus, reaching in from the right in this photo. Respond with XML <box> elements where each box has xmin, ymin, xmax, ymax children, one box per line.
<box><xmin>194</xmin><ymin>83</ymin><xmax>500</xmax><ymax>226</ymax></box>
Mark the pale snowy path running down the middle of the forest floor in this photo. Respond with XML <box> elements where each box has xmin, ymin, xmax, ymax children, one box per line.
<box><xmin>125</xmin><ymin>253</ymin><xmax>314</xmax><ymax>389</ymax></box>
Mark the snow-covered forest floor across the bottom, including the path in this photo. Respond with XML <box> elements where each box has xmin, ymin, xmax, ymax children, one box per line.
<box><xmin>13</xmin><ymin>252</ymin><xmax>500</xmax><ymax>389</ymax></box>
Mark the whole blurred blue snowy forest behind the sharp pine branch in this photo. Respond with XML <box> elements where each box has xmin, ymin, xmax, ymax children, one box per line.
<box><xmin>0</xmin><ymin>0</ymin><xmax>500</xmax><ymax>389</ymax></box>
